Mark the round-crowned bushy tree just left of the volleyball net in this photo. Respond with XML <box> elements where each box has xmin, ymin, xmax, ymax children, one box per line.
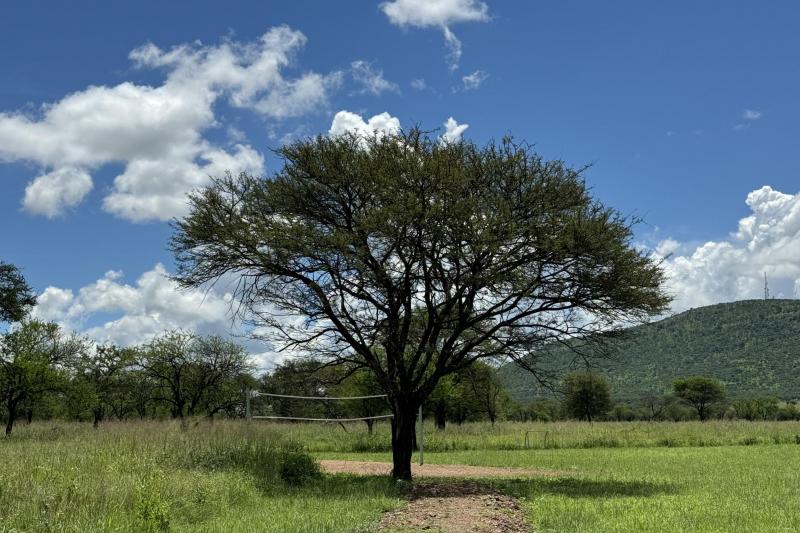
<box><xmin>138</xmin><ymin>331</ymin><xmax>249</xmax><ymax>419</ymax></box>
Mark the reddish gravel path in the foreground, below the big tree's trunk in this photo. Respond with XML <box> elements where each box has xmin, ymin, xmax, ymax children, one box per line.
<box><xmin>376</xmin><ymin>481</ymin><xmax>531</xmax><ymax>533</ymax></box>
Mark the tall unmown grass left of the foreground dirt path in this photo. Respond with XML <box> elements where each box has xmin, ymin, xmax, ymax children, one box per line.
<box><xmin>0</xmin><ymin>422</ymin><xmax>400</xmax><ymax>531</ymax></box>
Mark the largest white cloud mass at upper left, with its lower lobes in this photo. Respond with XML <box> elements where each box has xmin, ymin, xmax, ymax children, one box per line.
<box><xmin>0</xmin><ymin>26</ymin><xmax>342</xmax><ymax>221</ymax></box>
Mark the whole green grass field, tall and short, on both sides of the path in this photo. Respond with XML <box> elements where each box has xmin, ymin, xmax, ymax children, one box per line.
<box><xmin>0</xmin><ymin>422</ymin><xmax>800</xmax><ymax>532</ymax></box>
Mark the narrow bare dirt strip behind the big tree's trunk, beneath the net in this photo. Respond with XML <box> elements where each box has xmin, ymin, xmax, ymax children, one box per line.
<box><xmin>319</xmin><ymin>460</ymin><xmax>565</xmax><ymax>478</ymax></box>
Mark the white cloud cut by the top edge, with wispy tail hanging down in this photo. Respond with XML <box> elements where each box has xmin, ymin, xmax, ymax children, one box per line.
<box><xmin>381</xmin><ymin>0</ymin><xmax>489</xmax><ymax>70</ymax></box>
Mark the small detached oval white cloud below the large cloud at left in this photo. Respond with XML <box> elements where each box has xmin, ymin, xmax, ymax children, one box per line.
<box><xmin>22</xmin><ymin>167</ymin><xmax>92</xmax><ymax>218</ymax></box>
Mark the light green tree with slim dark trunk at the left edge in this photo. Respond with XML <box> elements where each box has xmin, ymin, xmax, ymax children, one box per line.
<box><xmin>0</xmin><ymin>320</ymin><xmax>88</xmax><ymax>437</ymax></box>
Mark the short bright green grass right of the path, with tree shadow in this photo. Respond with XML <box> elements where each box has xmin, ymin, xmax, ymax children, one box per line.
<box><xmin>323</xmin><ymin>445</ymin><xmax>800</xmax><ymax>532</ymax></box>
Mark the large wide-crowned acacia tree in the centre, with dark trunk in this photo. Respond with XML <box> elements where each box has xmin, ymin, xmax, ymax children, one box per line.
<box><xmin>171</xmin><ymin>130</ymin><xmax>668</xmax><ymax>478</ymax></box>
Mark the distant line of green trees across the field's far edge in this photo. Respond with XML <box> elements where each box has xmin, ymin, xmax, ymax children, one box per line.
<box><xmin>0</xmin><ymin>262</ymin><xmax>800</xmax><ymax>436</ymax></box>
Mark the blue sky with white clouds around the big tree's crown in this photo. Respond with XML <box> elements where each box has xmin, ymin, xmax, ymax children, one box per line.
<box><xmin>0</xmin><ymin>0</ymin><xmax>800</xmax><ymax>366</ymax></box>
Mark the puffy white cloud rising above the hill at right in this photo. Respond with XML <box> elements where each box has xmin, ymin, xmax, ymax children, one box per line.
<box><xmin>655</xmin><ymin>186</ymin><xmax>800</xmax><ymax>311</ymax></box>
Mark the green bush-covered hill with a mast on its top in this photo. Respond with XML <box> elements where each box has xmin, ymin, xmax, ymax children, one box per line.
<box><xmin>500</xmin><ymin>300</ymin><xmax>800</xmax><ymax>401</ymax></box>
